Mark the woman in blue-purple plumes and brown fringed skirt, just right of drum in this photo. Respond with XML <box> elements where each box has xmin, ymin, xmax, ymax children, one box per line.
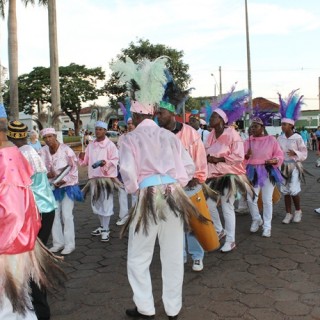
<box><xmin>205</xmin><ymin>89</ymin><xmax>254</xmax><ymax>252</ymax></box>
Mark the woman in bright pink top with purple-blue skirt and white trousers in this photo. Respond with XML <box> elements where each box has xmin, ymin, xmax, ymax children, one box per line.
<box><xmin>244</xmin><ymin>117</ymin><xmax>283</xmax><ymax>238</ymax></box>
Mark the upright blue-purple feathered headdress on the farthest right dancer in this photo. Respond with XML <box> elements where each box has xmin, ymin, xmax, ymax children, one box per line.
<box><xmin>278</xmin><ymin>89</ymin><xmax>303</xmax><ymax>125</ymax></box>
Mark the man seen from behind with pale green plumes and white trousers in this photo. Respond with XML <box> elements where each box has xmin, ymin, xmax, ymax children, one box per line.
<box><xmin>111</xmin><ymin>57</ymin><xmax>197</xmax><ymax>319</ymax></box>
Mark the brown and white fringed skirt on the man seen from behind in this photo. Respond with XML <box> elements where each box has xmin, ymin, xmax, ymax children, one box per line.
<box><xmin>121</xmin><ymin>184</ymin><xmax>208</xmax><ymax>236</ymax></box>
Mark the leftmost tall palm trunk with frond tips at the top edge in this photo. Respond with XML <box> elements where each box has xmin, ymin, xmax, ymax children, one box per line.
<box><xmin>0</xmin><ymin>0</ymin><xmax>48</xmax><ymax>119</ymax></box>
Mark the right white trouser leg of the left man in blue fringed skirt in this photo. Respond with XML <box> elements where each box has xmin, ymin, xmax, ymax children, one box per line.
<box><xmin>61</xmin><ymin>194</ymin><xmax>76</xmax><ymax>248</ymax></box>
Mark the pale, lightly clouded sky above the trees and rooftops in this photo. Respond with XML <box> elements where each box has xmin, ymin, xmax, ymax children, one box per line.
<box><xmin>0</xmin><ymin>0</ymin><xmax>320</xmax><ymax>110</ymax></box>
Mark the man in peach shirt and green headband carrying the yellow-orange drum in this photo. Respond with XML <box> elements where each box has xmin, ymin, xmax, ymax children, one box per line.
<box><xmin>157</xmin><ymin>101</ymin><xmax>208</xmax><ymax>271</ymax></box>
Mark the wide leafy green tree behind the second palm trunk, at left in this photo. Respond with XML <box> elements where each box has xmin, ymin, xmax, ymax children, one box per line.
<box><xmin>4</xmin><ymin>63</ymin><xmax>105</xmax><ymax>134</ymax></box>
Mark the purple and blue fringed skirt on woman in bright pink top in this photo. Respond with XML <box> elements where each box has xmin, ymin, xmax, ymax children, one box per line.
<box><xmin>246</xmin><ymin>164</ymin><xmax>283</xmax><ymax>187</ymax></box>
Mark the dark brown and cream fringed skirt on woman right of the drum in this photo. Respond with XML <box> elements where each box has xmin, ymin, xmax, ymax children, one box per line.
<box><xmin>206</xmin><ymin>174</ymin><xmax>256</xmax><ymax>201</ymax></box>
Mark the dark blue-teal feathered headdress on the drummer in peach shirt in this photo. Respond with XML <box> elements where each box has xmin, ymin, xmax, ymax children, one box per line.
<box><xmin>160</xmin><ymin>70</ymin><xmax>194</xmax><ymax>114</ymax></box>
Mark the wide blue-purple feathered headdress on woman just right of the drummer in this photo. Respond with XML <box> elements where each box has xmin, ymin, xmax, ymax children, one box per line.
<box><xmin>204</xmin><ymin>85</ymin><xmax>249</xmax><ymax>123</ymax></box>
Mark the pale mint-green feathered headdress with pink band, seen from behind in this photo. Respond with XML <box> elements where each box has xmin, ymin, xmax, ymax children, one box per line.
<box><xmin>110</xmin><ymin>56</ymin><xmax>168</xmax><ymax>114</ymax></box>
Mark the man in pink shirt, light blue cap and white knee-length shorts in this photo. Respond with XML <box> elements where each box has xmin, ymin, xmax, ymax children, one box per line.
<box><xmin>79</xmin><ymin>121</ymin><xmax>119</xmax><ymax>242</ymax></box>
